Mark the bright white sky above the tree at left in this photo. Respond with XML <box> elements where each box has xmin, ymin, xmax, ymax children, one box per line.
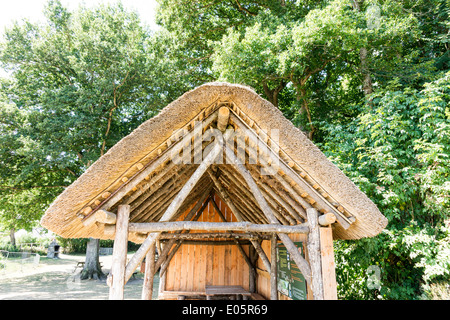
<box><xmin>0</xmin><ymin>0</ymin><xmax>157</xmax><ymax>36</ymax></box>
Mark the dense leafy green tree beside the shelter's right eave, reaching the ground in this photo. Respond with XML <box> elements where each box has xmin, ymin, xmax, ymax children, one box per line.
<box><xmin>322</xmin><ymin>72</ymin><xmax>450</xmax><ymax>299</ymax></box>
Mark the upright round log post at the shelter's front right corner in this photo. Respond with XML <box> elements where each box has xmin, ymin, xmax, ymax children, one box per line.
<box><xmin>306</xmin><ymin>208</ymin><xmax>323</xmax><ymax>300</ymax></box>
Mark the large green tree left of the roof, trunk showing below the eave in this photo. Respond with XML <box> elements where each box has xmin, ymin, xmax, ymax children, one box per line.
<box><xmin>0</xmin><ymin>1</ymin><xmax>151</xmax><ymax>278</ymax></box>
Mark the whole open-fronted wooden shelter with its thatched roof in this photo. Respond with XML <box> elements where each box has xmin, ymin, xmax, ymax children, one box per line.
<box><xmin>41</xmin><ymin>83</ymin><xmax>387</xmax><ymax>299</ymax></box>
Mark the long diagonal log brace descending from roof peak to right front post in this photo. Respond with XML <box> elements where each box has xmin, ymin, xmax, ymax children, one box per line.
<box><xmin>226</xmin><ymin>147</ymin><xmax>311</xmax><ymax>283</ymax></box>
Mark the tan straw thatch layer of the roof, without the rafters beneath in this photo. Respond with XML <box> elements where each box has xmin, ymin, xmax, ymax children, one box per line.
<box><xmin>41</xmin><ymin>83</ymin><xmax>387</xmax><ymax>241</ymax></box>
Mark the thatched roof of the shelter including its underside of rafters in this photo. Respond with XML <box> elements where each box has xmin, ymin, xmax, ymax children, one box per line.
<box><xmin>41</xmin><ymin>83</ymin><xmax>387</xmax><ymax>242</ymax></box>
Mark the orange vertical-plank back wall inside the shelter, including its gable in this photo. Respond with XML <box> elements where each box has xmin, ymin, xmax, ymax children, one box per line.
<box><xmin>165</xmin><ymin>196</ymin><xmax>249</xmax><ymax>292</ymax></box>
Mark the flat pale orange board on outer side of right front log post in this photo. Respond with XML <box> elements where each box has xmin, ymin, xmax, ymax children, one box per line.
<box><xmin>320</xmin><ymin>227</ymin><xmax>337</xmax><ymax>300</ymax></box>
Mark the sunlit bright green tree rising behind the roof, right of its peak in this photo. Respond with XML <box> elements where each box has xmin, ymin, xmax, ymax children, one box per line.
<box><xmin>212</xmin><ymin>0</ymin><xmax>424</xmax><ymax>139</ymax></box>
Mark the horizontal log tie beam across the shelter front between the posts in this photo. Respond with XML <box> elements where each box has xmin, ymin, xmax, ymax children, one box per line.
<box><xmin>129</xmin><ymin>221</ymin><xmax>309</xmax><ymax>234</ymax></box>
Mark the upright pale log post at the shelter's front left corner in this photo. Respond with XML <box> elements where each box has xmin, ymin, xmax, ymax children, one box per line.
<box><xmin>108</xmin><ymin>205</ymin><xmax>130</xmax><ymax>300</ymax></box>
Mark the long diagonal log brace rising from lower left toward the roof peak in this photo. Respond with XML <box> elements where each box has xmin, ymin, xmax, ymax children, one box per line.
<box><xmin>125</xmin><ymin>133</ymin><xmax>229</xmax><ymax>281</ymax></box>
